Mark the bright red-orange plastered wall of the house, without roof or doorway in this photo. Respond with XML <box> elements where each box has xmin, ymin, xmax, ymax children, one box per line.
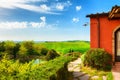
<box><xmin>90</xmin><ymin>16</ymin><xmax>120</xmax><ymax>54</ymax></box>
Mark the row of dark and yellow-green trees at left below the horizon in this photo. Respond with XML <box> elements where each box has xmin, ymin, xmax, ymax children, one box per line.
<box><xmin>0</xmin><ymin>41</ymin><xmax>57</xmax><ymax>62</ymax></box>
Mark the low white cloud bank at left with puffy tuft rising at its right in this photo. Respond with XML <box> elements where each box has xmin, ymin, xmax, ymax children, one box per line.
<box><xmin>0</xmin><ymin>16</ymin><xmax>57</xmax><ymax>30</ymax></box>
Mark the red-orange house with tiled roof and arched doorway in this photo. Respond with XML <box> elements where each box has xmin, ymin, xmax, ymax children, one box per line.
<box><xmin>87</xmin><ymin>6</ymin><xmax>120</xmax><ymax>62</ymax></box>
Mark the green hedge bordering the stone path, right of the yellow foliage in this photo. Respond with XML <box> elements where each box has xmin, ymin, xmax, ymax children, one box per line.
<box><xmin>25</xmin><ymin>56</ymin><xmax>72</xmax><ymax>80</ymax></box>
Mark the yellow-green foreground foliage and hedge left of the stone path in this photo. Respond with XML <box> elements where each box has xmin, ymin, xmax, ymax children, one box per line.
<box><xmin>0</xmin><ymin>56</ymin><xmax>72</xmax><ymax>80</ymax></box>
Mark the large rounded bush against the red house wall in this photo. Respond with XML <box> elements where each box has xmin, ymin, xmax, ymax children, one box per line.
<box><xmin>82</xmin><ymin>49</ymin><xmax>112</xmax><ymax>70</ymax></box>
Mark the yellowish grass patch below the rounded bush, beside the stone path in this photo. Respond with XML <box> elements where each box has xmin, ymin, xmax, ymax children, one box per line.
<box><xmin>81</xmin><ymin>67</ymin><xmax>113</xmax><ymax>80</ymax></box>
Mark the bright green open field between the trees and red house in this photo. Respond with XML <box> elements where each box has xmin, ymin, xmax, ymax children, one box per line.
<box><xmin>40</xmin><ymin>41</ymin><xmax>90</xmax><ymax>54</ymax></box>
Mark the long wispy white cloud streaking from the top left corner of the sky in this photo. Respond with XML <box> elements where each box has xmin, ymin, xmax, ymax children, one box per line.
<box><xmin>0</xmin><ymin>0</ymin><xmax>57</xmax><ymax>14</ymax></box>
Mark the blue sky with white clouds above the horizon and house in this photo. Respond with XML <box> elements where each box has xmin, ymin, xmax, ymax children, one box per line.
<box><xmin>0</xmin><ymin>0</ymin><xmax>120</xmax><ymax>41</ymax></box>
